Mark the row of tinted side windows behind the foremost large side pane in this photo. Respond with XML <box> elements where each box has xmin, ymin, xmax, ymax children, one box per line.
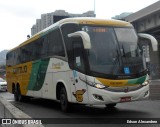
<box><xmin>7</xmin><ymin>36</ymin><xmax>48</xmax><ymax>65</ymax></box>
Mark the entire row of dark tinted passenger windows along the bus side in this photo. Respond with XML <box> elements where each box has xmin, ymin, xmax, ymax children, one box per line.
<box><xmin>7</xmin><ymin>29</ymin><xmax>65</xmax><ymax>65</ymax></box>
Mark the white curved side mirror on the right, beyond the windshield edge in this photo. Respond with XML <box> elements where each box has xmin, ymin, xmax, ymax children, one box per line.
<box><xmin>138</xmin><ymin>33</ymin><xmax>158</xmax><ymax>51</ymax></box>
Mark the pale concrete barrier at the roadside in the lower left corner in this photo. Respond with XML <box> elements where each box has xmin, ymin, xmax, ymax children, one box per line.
<box><xmin>0</xmin><ymin>97</ymin><xmax>43</xmax><ymax>127</ymax></box>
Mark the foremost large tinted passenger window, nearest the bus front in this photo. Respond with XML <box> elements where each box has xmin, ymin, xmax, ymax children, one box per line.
<box><xmin>48</xmin><ymin>29</ymin><xmax>65</xmax><ymax>56</ymax></box>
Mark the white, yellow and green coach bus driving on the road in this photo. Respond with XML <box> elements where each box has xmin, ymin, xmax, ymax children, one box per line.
<box><xmin>6</xmin><ymin>18</ymin><xmax>157</xmax><ymax>111</ymax></box>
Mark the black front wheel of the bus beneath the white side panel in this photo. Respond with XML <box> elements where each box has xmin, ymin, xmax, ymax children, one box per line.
<box><xmin>60</xmin><ymin>87</ymin><xmax>69</xmax><ymax>112</ymax></box>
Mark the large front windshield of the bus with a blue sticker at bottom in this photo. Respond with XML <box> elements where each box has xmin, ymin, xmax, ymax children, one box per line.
<box><xmin>82</xmin><ymin>26</ymin><xmax>146</xmax><ymax>75</ymax></box>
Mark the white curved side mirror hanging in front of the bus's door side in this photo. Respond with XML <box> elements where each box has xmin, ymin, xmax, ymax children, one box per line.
<box><xmin>68</xmin><ymin>31</ymin><xmax>91</xmax><ymax>49</ymax></box>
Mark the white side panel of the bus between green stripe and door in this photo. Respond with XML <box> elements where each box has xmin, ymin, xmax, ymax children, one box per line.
<box><xmin>41</xmin><ymin>58</ymin><xmax>71</xmax><ymax>100</ymax></box>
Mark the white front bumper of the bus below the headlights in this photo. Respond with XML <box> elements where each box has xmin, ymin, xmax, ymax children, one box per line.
<box><xmin>88</xmin><ymin>85</ymin><xmax>149</xmax><ymax>105</ymax></box>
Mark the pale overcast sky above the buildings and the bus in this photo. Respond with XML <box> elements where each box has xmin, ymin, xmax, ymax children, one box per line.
<box><xmin>0</xmin><ymin>0</ymin><xmax>158</xmax><ymax>51</ymax></box>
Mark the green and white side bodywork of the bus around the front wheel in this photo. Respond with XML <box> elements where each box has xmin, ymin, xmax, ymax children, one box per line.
<box><xmin>27</xmin><ymin>58</ymin><xmax>73</xmax><ymax>101</ymax></box>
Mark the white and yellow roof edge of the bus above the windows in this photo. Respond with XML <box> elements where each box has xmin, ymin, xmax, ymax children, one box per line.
<box><xmin>7</xmin><ymin>17</ymin><xmax>132</xmax><ymax>51</ymax></box>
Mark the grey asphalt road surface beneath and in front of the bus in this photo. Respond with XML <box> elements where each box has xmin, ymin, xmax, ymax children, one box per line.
<box><xmin>12</xmin><ymin>99</ymin><xmax>160</xmax><ymax>127</ymax></box>
